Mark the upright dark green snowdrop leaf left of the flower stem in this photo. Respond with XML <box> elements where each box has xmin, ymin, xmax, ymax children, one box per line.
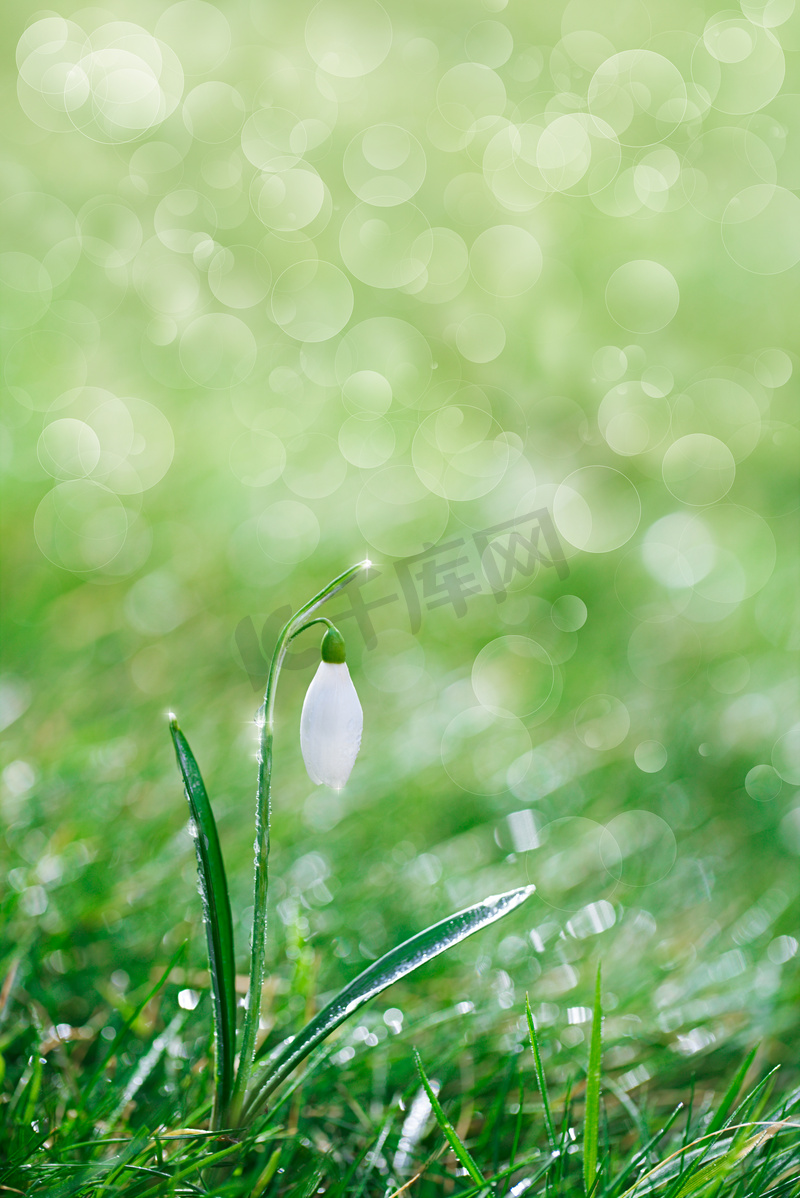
<box><xmin>169</xmin><ymin>716</ymin><xmax>236</xmax><ymax>1118</ymax></box>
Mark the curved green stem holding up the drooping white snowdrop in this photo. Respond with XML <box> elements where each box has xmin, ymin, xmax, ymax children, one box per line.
<box><xmin>229</xmin><ymin>561</ymin><xmax>371</xmax><ymax>1127</ymax></box>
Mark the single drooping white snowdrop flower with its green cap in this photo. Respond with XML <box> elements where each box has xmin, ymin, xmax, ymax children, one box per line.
<box><xmin>301</xmin><ymin>628</ymin><xmax>364</xmax><ymax>791</ymax></box>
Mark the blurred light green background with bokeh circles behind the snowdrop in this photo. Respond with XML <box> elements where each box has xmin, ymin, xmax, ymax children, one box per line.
<box><xmin>0</xmin><ymin>0</ymin><xmax>800</xmax><ymax>1089</ymax></box>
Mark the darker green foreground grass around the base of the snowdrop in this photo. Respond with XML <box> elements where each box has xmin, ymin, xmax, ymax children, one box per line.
<box><xmin>0</xmin><ymin>948</ymin><xmax>800</xmax><ymax>1198</ymax></box>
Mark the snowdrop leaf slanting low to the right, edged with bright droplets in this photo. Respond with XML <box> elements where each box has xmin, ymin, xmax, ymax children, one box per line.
<box><xmin>244</xmin><ymin>885</ymin><xmax>537</xmax><ymax>1105</ymax></box>
